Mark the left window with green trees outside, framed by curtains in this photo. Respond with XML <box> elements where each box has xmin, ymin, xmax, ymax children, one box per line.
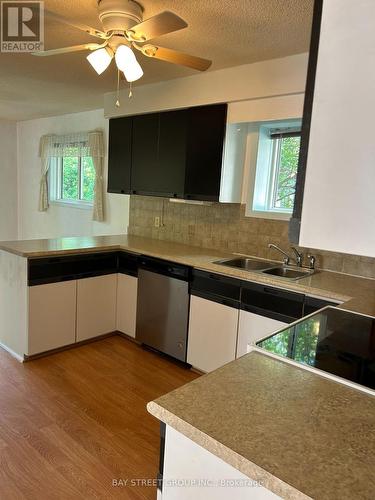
<box><xmin>51</xmin><ymin>156</ymin><xmax>95</xmax><ymax>207</ymax></box>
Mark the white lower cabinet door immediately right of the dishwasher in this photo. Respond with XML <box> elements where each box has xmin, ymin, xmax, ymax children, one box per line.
<box><xmin>187</xmin><ymin>295</ymin><xmax>238</xmax><ymax>372</ymax></box>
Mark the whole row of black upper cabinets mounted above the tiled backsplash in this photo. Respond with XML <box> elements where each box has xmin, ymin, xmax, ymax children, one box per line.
<box><xmin>108</xmin><ymin>104</ymin><xmax>227</xmax><ymax>201</ymax></box>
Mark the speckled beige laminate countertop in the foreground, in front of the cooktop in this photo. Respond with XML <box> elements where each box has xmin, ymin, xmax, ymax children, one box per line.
<box><xmin>148</xmin><ymin>351</ymin><xmax>375</xmax><ymax>500</ymax></box>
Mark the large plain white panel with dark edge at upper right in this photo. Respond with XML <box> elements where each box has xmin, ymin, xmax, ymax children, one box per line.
<box><xmin>300</xmin><ymin>0</ymin><xmax>375</xmax><ymax>257</ymax></box>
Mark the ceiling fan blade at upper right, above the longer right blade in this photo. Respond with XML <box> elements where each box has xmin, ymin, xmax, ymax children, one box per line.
<box><xmin>126</xmin><ymin>11</ymin><xmax>187</xmax><ymax>42</ymax></box>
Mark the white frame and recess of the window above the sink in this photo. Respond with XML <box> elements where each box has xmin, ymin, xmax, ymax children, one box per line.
<box><xmin>245</xmin><ymin>120</ymin><xmax>301</xmax><ymax>221</ymax></box>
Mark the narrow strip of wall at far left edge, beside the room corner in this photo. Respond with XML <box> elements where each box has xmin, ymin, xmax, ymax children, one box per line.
<box><xmin>0</xmin><ymin>120</ymin><xmax>17</xmax><ymax>240</ymax></box>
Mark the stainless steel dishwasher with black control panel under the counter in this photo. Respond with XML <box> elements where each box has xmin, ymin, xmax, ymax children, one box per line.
<box><xmin>135</xmin><ymin>257</ymin><xmax>189</xmax><ymax>362</ymax></box>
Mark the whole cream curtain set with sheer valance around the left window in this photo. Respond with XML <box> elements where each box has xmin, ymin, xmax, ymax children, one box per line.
<box><xmin>39</xmin><ymin>130</ymin><xmax>104</xmax><ymax>222</ymax></box>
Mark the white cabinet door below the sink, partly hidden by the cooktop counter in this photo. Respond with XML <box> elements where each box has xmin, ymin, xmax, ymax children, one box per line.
<box><xmin>236</xmin><ymin>310</ymin><xmax>288</xmax><ymax>358</ymax></box>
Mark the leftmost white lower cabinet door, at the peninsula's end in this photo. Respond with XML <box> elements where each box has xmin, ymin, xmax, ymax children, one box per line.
<box><xmin>26</xmin><ymin>280</ymin><xmax>77</xmax><ymax>356</ymax></box>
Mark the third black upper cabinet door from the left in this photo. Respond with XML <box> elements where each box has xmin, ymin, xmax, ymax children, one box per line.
<box><xmin>158</xmin><ymin>109</ymin><xmax>189</xmax><ymax>198</ymax></box>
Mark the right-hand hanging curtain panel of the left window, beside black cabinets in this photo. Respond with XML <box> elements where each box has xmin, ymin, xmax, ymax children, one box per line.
<box><xmin>88</xmin><ymin>131</ymin><xmax>104</xmax><ymax>222</ymax></box>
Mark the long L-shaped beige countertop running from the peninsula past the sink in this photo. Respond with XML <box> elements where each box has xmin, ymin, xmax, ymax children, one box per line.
<box><xmin>0</xmin><ymin>235</ymin><xmax>375</xmax><ymax>316</ymax></box>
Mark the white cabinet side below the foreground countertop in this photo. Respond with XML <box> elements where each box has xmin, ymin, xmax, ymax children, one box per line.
<box><xmin>163</xmin><ymin>426</ymin><xmax>281</xmax><ymax>500</ymax></box>
